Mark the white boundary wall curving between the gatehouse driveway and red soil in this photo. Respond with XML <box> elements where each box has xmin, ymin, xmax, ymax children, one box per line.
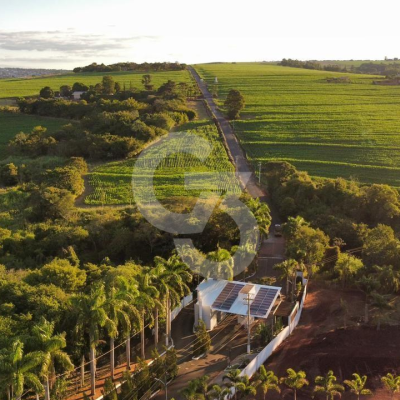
<box><xmin>240</xmin><ymin>282</ymin><xmax>307</xmax><ymax>378</ymax></box>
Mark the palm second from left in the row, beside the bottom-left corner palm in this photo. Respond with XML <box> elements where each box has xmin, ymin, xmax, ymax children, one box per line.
<box><xmin>32</xmin><ymin>318</ymin><xmax>74</xmax><ymax>400</ymax></box>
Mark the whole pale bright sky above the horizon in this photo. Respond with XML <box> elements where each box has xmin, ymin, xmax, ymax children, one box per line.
<box><xmin>0</xmin><ymin>0</ymin><xmax>400</xmax><ymax>69</ymax></box>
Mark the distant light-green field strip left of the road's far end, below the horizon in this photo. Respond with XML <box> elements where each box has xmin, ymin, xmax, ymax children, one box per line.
<box><xmin>0</xmin><ymin>71</ymin><xmax>190</xmax><ymax>99</ymax></box>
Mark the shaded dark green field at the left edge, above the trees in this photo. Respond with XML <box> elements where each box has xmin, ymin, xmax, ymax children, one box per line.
<box><xmin>0</xmin><ymin>112</ymin><xmax>71</xmax><ymax>159</ymax></box>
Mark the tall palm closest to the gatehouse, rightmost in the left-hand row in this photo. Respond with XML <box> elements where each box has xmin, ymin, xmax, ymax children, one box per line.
<box><xmin>154</xmin><ymin>254</ymin><xmax>193</xmax><ymax>346</ymax></box>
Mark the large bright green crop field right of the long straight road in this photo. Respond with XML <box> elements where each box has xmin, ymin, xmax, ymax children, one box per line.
<box><xmin>196</xmin><ymin>63</ymin><xmax>400</xmax><ymax>188</ymax></box>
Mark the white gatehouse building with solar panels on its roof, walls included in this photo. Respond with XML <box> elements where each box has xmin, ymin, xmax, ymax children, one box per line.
<box><xmin>194</xmin><ymin>279</ymin><xmax>281</xmax><ymax>330</ymax></box>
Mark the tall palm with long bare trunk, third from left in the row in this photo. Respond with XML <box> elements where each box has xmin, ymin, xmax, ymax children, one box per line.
<box><xmin>71</xmin><ymin>284</ymin><xmax>114</xmax><ymax>396</ymax></box>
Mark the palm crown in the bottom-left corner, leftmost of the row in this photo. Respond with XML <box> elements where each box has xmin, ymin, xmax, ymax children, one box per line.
<box><xmin>0</xmin><ymin>339</ymin><xmax>43</xmax><ymax>400</ymax></box>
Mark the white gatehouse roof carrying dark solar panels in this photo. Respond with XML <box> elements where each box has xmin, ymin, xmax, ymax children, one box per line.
<box><xmin>197</xmin><ymin>279</ymin><xmax>282</xmax><ymax>318</ymax></box>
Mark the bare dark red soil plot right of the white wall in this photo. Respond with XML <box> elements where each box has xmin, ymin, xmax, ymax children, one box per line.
<box><xmin>265</xmin><ymin>283</ymin><xmax>400</xmax><ymax>400</ymax></box>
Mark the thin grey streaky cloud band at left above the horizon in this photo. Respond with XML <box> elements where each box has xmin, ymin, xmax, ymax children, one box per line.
<box><xmin>0</xmin><ymin>30</ymin><xmax>157</xmax><ymax>56</ymax></box>
